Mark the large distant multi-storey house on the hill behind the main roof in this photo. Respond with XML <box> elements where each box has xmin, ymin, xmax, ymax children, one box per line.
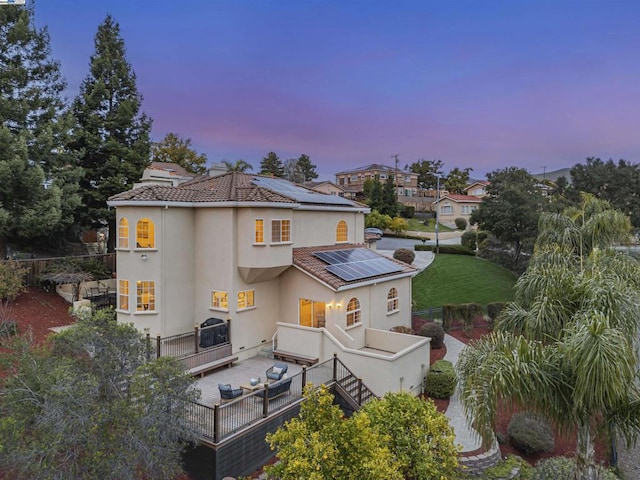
<box><xmin>336</xmin><ymin>163</ymin><xmax>418</xmax><ymax>204</ymax></box>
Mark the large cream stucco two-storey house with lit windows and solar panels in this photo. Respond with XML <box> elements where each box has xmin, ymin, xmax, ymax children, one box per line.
<box><xmin>108</xmin><ymin>172</ymin><xmax>429</xmax><ymax>395</ymax></box>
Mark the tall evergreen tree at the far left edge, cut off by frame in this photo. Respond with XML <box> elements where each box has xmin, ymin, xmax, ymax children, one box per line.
<box><xmin>0</xmin><ymin>5</ymin><xmax>81</xmax><ymax>258</ymax></box>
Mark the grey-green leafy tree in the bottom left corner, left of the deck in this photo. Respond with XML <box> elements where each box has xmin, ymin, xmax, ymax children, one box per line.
<box><xmin>0</xmin><ymin>313</ymin><xmax>199</xmax><ymax>480</ymax></box>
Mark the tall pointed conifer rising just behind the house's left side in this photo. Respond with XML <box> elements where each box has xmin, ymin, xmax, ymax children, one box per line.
<box><xmin>73</xmin><ymin>15</ymin><xmax>151</xmax><ymax>251</ymax></box>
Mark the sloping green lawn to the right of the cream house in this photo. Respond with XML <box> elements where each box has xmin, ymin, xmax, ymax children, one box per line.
<box><xmin>413</xmin><ymin>254</ymin><xmax>517</xmax><ymax>310</ymax></box>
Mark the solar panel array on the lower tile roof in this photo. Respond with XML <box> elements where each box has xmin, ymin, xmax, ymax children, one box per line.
<box><xmin>314</xmin><ymin>248</ymin><xmax>402</xmax><ymax>282</ymax></box>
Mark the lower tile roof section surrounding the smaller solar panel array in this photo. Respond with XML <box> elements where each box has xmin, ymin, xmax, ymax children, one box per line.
<box><xmin>293</xmin><ymin>244</ymin><xmax>418</xmax><ymax>290</ymax></box>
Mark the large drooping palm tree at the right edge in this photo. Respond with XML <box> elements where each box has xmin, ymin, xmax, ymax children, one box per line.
<box><xmin>457</xmin><ymin>195</ymin><xmax>640</xmax><ymax>480</ymax></box>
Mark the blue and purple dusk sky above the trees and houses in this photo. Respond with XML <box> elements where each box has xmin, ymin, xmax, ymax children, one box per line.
<box><xmin>33</xmin><ymin>0</ymin><xmax>640</xmax><ymax>179</ymax></box>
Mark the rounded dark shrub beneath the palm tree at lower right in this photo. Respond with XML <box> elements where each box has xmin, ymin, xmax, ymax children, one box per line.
<box><xmin>507</xmin><ymin>412</ymin><xmax>554</xmax><ymax>455</ymax></box>
